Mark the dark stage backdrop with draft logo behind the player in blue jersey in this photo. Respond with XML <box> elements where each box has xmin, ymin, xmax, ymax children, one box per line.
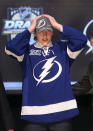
<box><xmin>0</xmin><ymin>0</ymin><xmax>93</xmax><ymax>131</ymax></box>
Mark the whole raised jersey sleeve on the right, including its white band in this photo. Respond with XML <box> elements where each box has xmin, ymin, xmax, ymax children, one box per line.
<box><xmin>61</xmin><ymin>26</ymin><xmax>87</xmax><ymax>66</ymax></box>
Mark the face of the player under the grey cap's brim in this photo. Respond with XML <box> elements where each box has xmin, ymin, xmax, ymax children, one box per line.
<box><xmin>35</xmin><ymin>30</ymin><xmax>53</xmax><ymax>46</ymax></box>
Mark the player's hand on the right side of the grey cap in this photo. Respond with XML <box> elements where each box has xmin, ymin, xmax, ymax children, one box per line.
<box><xmin>42</xmin><ymin>14</ymin><xmax>63</xmax><ymax>32</ymax></box>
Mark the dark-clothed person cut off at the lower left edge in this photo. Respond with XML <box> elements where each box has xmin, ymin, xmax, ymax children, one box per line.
<box><xmin>0</xmin><ymin>74</ymin><xmax>14</xmax><ymax>131</ymax></box>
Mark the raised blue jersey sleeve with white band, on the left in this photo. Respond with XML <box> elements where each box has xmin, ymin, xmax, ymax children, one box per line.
<box><xmin>5</xmin><ymin>30</ymin><xmax>31</xmax><ymax>61</ymax></box>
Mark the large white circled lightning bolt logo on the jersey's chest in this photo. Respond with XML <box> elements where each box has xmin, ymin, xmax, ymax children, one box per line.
<box><xmin>33</xmin><ymin>56</ymin><xmax>62</xmax><ymax>85</ymax></box>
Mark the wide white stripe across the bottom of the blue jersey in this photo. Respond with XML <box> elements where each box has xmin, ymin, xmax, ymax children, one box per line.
<box><xmin>21</xmin><ymin>99</ymin><xmax>77</xmax><ymax>115</ymax></box>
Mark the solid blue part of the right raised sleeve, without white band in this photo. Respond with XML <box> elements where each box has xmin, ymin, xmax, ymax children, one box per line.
<box><xmin>61</xmin><ymin>26</ymin><xmax>87</xmax><ymax>52</ymax></box>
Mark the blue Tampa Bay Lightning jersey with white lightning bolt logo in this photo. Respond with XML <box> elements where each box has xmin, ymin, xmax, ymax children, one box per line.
<box><xmin>6</xmin><ymin>26</ymin><xmax>87</xmax><ymax>123</ymax></box>
